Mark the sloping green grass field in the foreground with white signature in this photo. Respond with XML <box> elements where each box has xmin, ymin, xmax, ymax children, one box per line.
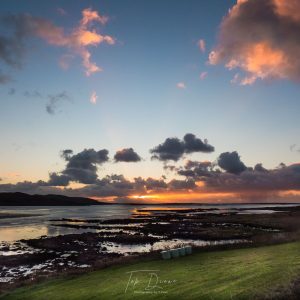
<box><xmin>0</xmin><ymin>242</ymin><xmax>300</xmax><ymax>300</ymax></box>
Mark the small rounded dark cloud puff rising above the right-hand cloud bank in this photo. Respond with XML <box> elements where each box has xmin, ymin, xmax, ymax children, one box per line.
<box><xmin>218</xmin><ymin>151</ymin><xmax>247</xmax><ymax>174</ymax></box>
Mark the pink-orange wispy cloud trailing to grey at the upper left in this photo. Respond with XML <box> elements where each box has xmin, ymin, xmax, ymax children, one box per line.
<box><xmin>0</xmin><ymin>8</ymin><xmax>115</xmax><ymax>78</ymax></box>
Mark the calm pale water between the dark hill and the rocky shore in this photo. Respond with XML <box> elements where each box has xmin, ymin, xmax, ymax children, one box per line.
<box><xmin>0</xmin><ymin>204</ymin><xmax>294</xmax><ymax>242</ymax></box>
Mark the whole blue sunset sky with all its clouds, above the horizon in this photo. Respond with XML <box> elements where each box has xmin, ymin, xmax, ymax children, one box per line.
<box><xmin>0</xmin><ymin>0</ymin><xmax>300</xmax><ymax>202</ymax></box>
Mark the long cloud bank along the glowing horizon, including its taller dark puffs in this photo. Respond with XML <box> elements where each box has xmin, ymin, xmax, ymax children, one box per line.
<box><xmin>0</xmin><ymin>149</ymin><xmax>300</xmax><ymax>202</ymax></box>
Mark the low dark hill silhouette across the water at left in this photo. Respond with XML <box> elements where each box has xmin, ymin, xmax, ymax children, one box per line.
<box><xmin>0</xmin><ymin>193</ymin><xmax>108</xmax><ymax>206</ymax></box>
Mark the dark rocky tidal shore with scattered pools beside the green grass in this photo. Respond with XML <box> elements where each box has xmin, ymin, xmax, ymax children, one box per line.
<box><xmin>0</xmin><ymin>207</ymin><xmax>300</xmax><ymax>292</ymax></box>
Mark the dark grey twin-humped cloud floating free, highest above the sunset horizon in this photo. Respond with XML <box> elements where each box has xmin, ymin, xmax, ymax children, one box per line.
<box><xmin>150</xmin><ymin>133</ymin><xmax>214</xmax><ymax>161</ymax></box>
